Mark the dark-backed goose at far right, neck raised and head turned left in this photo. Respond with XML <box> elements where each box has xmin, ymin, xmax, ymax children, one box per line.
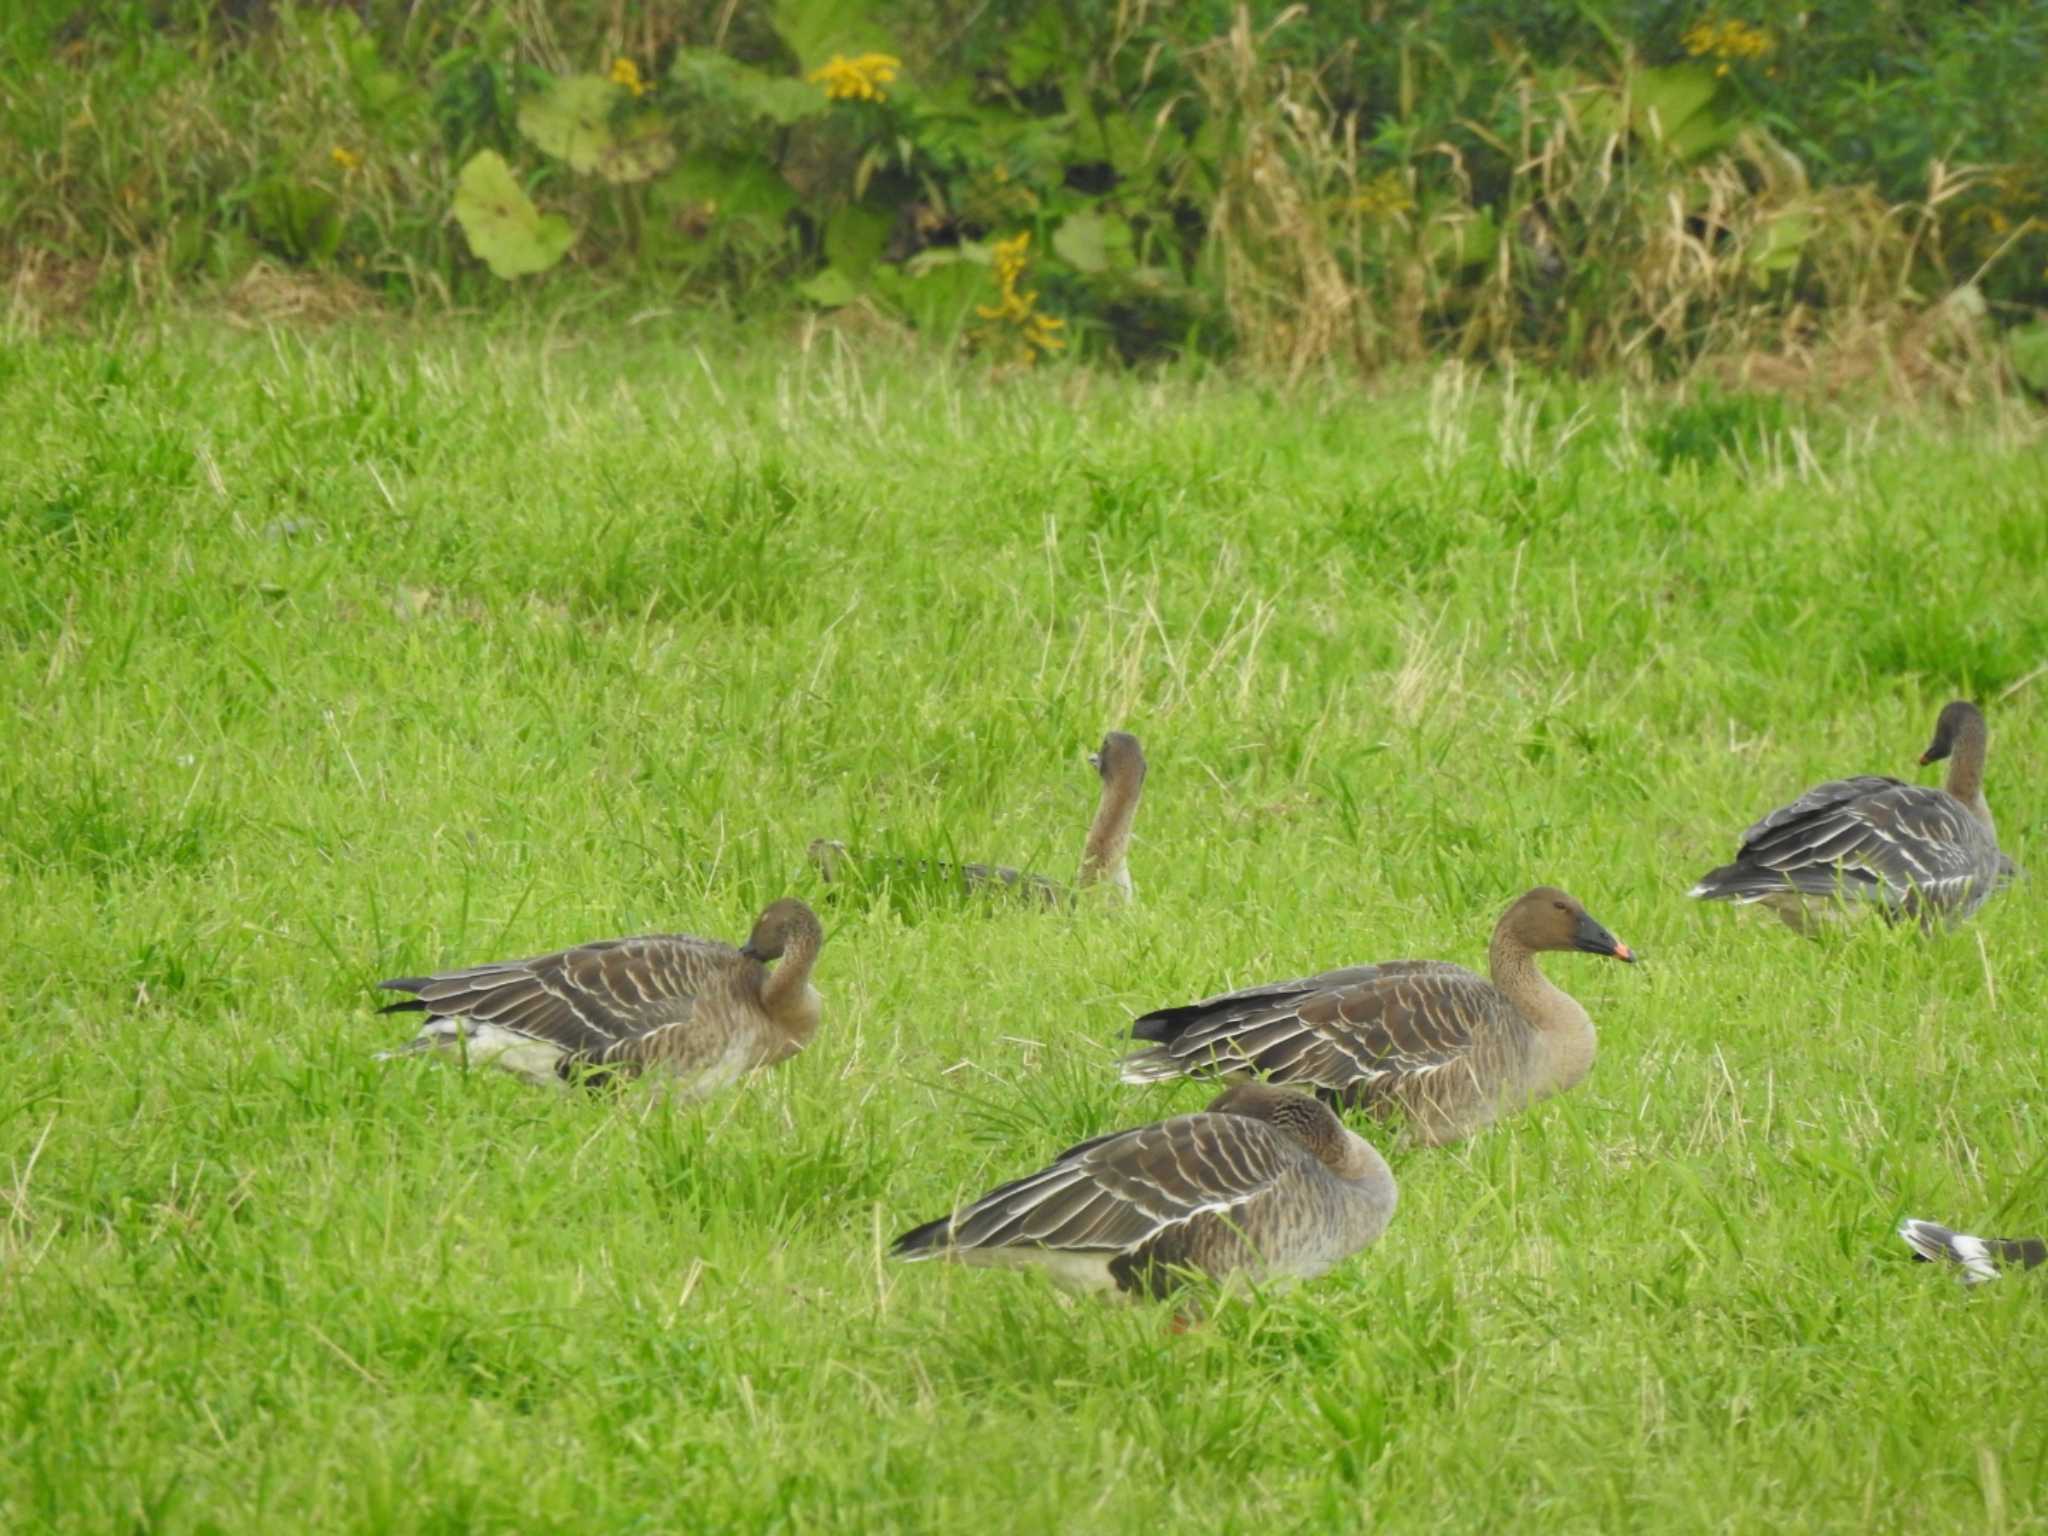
<box><xmin>1690</xmin><ymin>698</ymin><xmax>2017</xmax><ymax>934</ymax></box>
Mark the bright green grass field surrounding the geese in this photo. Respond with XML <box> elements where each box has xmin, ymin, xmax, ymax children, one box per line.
<box><xmin>0</xmin><ymin>324</ymin><xmax>2048</xmax><ymax>1532</ymax></box>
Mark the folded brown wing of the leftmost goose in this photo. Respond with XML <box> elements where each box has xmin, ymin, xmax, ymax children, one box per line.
<box><xmin>379</xmin><ymin>936</ymin><xmax>739</xmax><ymax>1061</ymax></box>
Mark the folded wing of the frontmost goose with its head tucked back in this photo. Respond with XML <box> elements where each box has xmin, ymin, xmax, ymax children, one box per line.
<box><xmin>950</xmin><ymin>1114</ymin><xmax>1303</xmax><ymax>1253</ymax></box>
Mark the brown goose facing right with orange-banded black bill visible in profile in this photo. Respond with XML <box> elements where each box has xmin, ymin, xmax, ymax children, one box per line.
<box><xmin>1122</xmin><ymin>885</ymin><xmax>1636</xmax><ymax>1147</ymax></box>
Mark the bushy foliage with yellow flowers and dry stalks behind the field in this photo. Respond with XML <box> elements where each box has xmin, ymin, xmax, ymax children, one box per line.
<box><xmin>0</xmin><ymin>0</ymin><xmax>2048</xmax><ymax>385</ymax></box>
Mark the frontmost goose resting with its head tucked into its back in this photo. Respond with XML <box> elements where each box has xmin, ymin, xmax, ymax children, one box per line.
<box><xmin>891</xmin><ymin>1083</ymin><xmax>1397</xmax><ymax>1296</ymax></box>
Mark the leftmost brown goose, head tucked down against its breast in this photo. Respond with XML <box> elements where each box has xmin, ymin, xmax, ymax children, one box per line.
<box><xmin>377</xmin><ymin>897</ymin><xmax>825</xmax><ymax>1098</ymax></box>
